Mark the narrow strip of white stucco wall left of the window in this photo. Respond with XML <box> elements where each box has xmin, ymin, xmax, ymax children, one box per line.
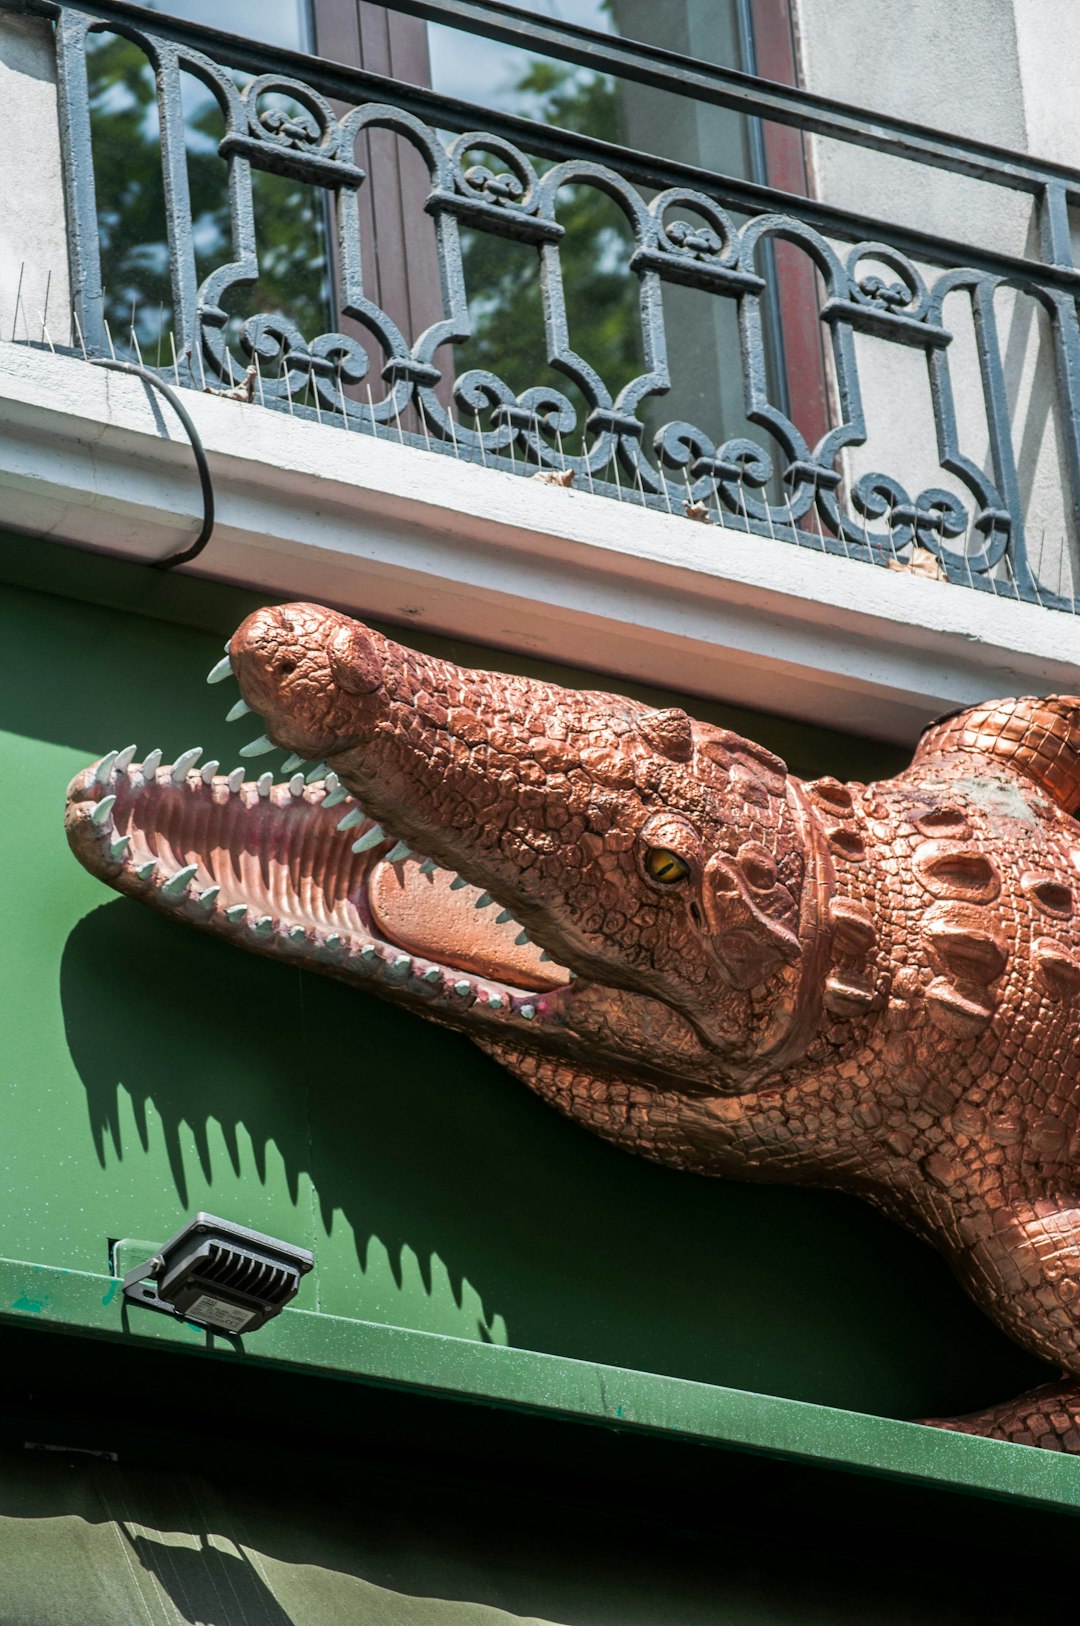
<box><xmin>0</xmin><ymin>13</ymin><xmax>72</xmax><ymax>352</ymax></box>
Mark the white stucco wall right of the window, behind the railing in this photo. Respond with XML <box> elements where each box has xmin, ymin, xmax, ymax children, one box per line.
<box><xmin>794</xmin><ymin>0</ymin><xmax>1080</xmax><ymax>590</ymax></box>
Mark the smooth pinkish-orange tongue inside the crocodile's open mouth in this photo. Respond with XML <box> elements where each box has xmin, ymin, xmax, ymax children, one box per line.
<box><xmin>368</xmin><ymin>859</ymin><xmax>569</xmax><ymax>992</ymax></box>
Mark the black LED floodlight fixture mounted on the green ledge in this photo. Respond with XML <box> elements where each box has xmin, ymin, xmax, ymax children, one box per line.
<box><xmin>124</xmin><ymin>1213</ymin><xmax>316</xmax><ymax>1333</ymax></box>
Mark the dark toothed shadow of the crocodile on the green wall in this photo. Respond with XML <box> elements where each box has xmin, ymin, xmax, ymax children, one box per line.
<box><xmin>60</xmin><ymin>899</ymin><xmax>1044</xmax><ymax>1416</ymax></box>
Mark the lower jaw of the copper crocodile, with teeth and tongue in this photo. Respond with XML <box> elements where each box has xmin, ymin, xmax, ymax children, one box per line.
<box><xmin>67</xmin><ymin>751</ymin><xmax>574</xmax><ymax>1029</ymax></box>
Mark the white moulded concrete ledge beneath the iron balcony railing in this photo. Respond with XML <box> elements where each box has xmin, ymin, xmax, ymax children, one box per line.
<box><xmin>0</xmin><ymin>343</ymin><xmax>1080</xmax><ymax>741</ymax></box>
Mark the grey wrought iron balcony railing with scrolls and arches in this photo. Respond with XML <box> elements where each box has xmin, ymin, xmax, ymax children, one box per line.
<box><xmin>0</xmin><ymin>0</ymin><xmax>1080</xmax><ymax>610</ymax></box>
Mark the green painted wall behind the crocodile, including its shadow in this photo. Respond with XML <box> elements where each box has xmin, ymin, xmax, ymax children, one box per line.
<box><xmin>0</xmin><ymin>540</ymin><xmax>1039</xmax><ymax>1416</ymax></box>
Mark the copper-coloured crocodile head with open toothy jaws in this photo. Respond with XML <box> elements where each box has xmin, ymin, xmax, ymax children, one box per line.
<box><xmin>67</xmin><ymin>603</ymin><xmax>826</xmax><ymax>1093</ymax></box>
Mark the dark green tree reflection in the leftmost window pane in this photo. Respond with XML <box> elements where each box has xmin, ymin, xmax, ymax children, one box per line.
<box><xmin>88</xmin><ymin>34</ymin><xmax>330</xmax><ymax>364</ymax></box>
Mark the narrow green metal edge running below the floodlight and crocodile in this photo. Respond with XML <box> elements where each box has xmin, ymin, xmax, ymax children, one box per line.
<box><xmin>0</xmin><ymin>1259</ymin><xmax>1080</xmax><ymax>1512</ymax></box>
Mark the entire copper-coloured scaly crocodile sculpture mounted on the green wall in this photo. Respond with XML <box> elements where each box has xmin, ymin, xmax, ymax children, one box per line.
<box><xmin>67</xmin><ymin>605</ymin><xmax>1080</xmax><ymax>1450</ymax></box>
